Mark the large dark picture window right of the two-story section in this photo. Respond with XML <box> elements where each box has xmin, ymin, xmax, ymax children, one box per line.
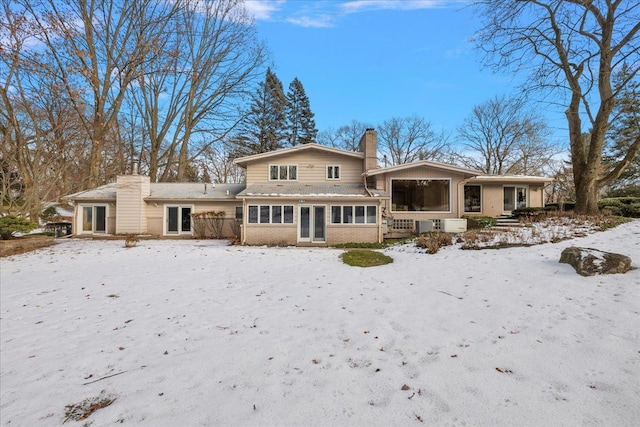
<box><xmin>391</xmin><ymin>179</ymin><xmax>451</xmax><ymax>212</ymax></box>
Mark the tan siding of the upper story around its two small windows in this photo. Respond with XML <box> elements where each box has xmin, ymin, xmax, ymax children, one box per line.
<box><xmin>247</xmin><ymin>150</ymin><xmax>363</xmax><ymax>185</ymax></box>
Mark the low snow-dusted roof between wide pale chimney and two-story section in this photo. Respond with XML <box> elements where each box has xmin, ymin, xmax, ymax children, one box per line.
<box><xmin>144</xmin><ymin>182</ymin><xmax>245</xmax><ymax>200</ymax></box>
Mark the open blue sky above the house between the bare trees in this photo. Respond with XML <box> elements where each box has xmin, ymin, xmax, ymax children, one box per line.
<box><xmin>246</xmin><ymin>0</ymin><xmax>563</xmax><ymax>144</ymax></box>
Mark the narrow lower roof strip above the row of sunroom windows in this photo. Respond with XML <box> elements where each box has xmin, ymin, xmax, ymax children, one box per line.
<box><xmin>238</xmin><ymin>184</ymin><xmax>389</xmax><ymax>197</ymax></box>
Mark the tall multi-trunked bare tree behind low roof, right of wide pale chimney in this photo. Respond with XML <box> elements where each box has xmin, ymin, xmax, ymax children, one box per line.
<box><xmin>132</xmin><ymin>0</ymin><xmax>265</xmax><ymax>181</ymax></box>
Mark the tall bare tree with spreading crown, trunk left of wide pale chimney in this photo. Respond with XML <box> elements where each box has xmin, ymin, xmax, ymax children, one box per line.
<box><xmin>12</xmin><ymin>0</ymin><xmax>181</xmax><ymax>186</ymax></box>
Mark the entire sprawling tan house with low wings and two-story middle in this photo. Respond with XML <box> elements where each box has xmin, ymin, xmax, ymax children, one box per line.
<box><xmin>66</xmin><ymin>129</ymin><xmax>552</xmax><ymax>245</ymax></box>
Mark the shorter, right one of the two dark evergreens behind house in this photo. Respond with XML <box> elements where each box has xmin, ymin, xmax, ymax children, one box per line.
<box><xmin>286</xmin><ymin>77</ymin><xmax>318</xmax><ymax>146</ymax></box>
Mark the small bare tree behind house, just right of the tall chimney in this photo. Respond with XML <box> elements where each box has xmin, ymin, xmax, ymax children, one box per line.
<box><xmin>378</xmin><ymin>116</ymin><xmax>448</xmax><ymax>166</ymax></box>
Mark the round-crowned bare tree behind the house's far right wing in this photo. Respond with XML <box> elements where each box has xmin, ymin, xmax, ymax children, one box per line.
<box><xmin>458</xmin><ymin>96</ymin><xmax>558</xmax><ymax>175</ymax></box>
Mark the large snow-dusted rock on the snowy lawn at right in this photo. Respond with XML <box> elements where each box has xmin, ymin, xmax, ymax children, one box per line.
<box><xmin>560</xmin><ymin>246</ymin><xmax>631</xmax><ymax>276</ymax></box>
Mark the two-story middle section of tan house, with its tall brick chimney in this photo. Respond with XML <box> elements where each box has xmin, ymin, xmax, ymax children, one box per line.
<box><xmin>235</xmin><ymin>129</ymin><xmax>389</xmax><ymax>245</ymax></box>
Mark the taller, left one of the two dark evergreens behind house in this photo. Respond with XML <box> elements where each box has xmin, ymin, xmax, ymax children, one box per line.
<box><xmin>233</xmin><ymin>68</ymin><xmax>286</xmax><ymax>156</ymax></box>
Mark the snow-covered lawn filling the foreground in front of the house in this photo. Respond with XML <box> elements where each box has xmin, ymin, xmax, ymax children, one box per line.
<box><xmin>0</xmin><ymin>221</ymin><xmax>640</xmax><ymax>426</ymax></box>
